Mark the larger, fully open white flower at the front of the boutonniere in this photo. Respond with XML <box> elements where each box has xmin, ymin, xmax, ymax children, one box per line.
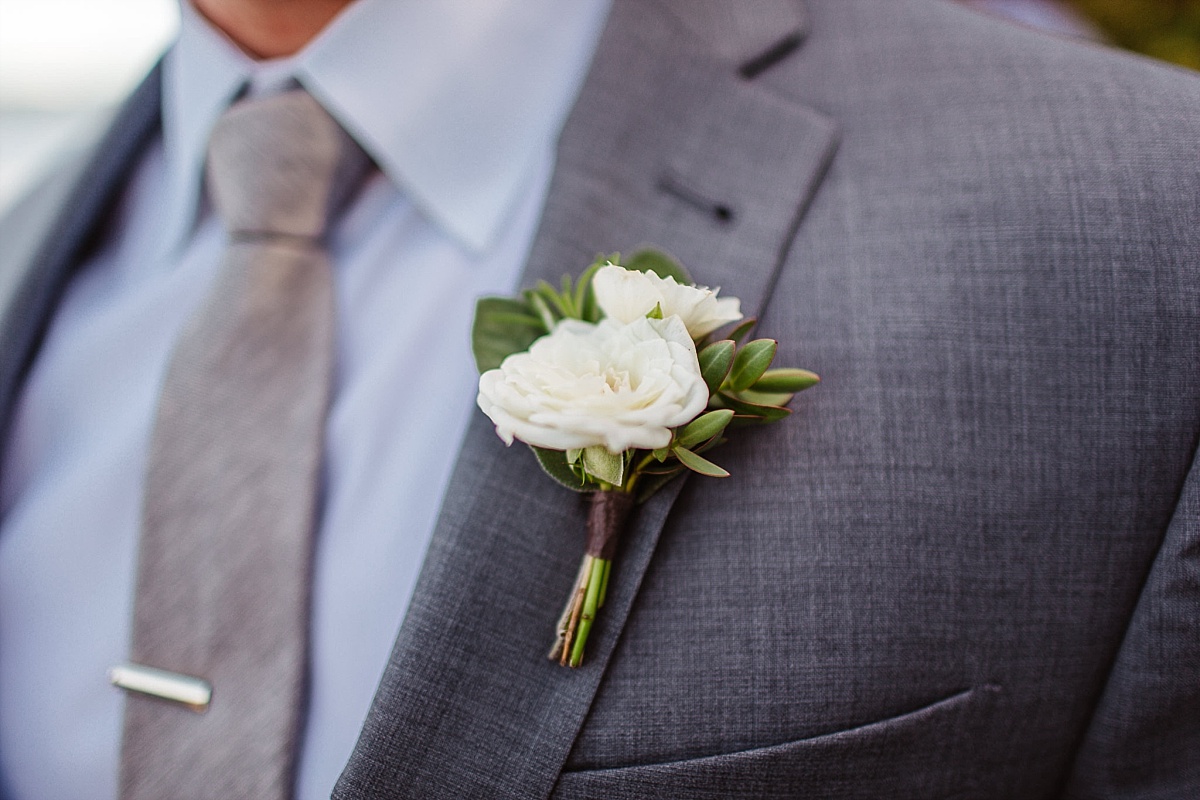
<box><xmin>478</xmin><ymin>317</ymin><xmax>708</xmax><ymax>453</ymax></box>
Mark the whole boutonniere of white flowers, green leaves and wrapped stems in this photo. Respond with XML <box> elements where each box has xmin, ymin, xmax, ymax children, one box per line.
<box><xmin>472</xmin><ymin>251</ymin><xmax>820</xmax><ymax>667</ymax></box>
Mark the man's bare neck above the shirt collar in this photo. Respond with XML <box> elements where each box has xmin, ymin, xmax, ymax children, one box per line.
<box><xmin>190</xmin><ymin>0</ymin><xmax>353</xmax><ymax>59</ymax></box>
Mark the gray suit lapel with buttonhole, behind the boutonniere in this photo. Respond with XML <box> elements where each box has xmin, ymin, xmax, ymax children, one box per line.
<box><xmin>335</xmin><ymin>0</ymin><xmax>835</xmax><ymax>799</ymax></box>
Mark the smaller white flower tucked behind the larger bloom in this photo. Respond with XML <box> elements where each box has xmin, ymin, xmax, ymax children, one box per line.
<box><xmin>592</xmin><ymin>264</ymin><xmax>742</xmax><ymax>339</ymax></box>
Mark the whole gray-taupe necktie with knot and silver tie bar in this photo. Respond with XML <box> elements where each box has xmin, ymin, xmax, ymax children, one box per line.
<box><xmin>113</xmin><ymin>91</ymin><xmax>368</xmax><ymax>800</ymax></box>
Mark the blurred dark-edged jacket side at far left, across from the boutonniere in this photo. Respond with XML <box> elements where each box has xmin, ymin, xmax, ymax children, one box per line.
<box><xmin>0</xmin><ymin>62</ymin><xmax>162</xmax><ymax>479</ymax></box>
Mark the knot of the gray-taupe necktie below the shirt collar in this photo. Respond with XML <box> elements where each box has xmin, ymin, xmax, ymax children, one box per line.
<box><xmin>208</xmin><ymin>90</ymin><xmax>370</xmax><ymax>239</ymax></box>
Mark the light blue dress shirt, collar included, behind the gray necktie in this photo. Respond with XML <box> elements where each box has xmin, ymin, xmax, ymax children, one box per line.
<box><xmin>0</xmin><ymin>0</ymin><xmax>607</xmax><ymax>800</ymax></box>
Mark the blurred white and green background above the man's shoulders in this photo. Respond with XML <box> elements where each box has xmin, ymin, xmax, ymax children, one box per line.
<box><xmin>0</xmin><ymin>0</ymin><xmax>1200</xmax><ymax>211</ymax></box>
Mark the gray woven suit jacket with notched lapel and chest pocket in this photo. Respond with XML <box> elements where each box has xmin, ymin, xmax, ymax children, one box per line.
<box><xmin>0</xmin><ymin>0</ymin><xmax>1200</xmax><ymax>799</ymax></box>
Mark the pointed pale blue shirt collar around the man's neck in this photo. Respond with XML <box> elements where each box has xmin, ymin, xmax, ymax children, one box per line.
<box><xmin>163</xmin><ymin>0</ymin><xmax>610</xmax><ymax>252</ymax></box>
